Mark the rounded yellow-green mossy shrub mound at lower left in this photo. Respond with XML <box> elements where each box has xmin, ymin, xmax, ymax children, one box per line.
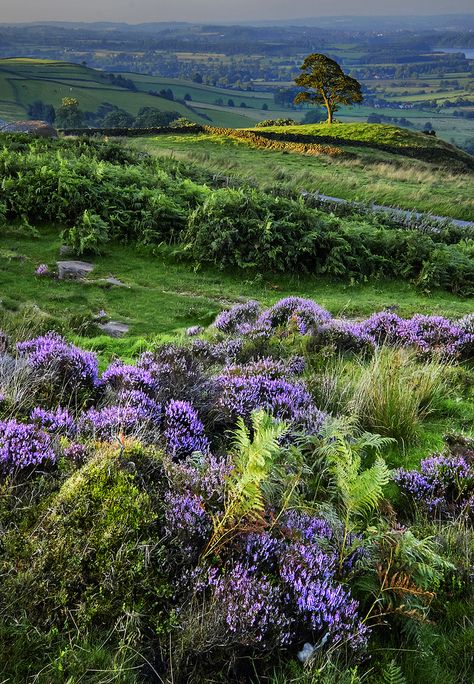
<box><xmin>1</xmin><ymin>446</ymin><xmax>166</xmax><ymax>632</ymax></box>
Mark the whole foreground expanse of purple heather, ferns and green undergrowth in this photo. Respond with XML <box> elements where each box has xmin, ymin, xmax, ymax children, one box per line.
<box><xmin>0</xmin><ymin>297</ymin><xmax>474</xmax><ymax>684</ymax></box>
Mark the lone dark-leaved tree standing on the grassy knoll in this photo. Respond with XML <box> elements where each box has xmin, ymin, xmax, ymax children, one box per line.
<box><xmin>295</xmin><ymin>54</ymin><xmax>363</xmax><ymax>123</ymax></box>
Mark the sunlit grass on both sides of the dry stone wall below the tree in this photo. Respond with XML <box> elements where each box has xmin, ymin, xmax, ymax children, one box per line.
<box><xmin>133</xmin><ymin>129</ymin><xmax>474</xmax><ymax>220</ymax></box>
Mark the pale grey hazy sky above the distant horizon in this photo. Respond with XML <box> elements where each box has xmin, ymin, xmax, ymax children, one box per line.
<box><xmin>0</xmin><ymin>0</ymin><xmax>473</xmax><ymax>24</ymax></box>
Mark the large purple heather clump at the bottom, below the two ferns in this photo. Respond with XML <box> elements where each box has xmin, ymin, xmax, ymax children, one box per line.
<box><xmin>187</xmin><ymin>511</ymin><xmax>369</xmax><ymax>649</ymax></box>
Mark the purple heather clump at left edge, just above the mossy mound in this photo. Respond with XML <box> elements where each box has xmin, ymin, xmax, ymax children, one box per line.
<box><xmin>0</xmin><ymin>420</ymin><xmax>56</xmax><ymax>473</ymax></box>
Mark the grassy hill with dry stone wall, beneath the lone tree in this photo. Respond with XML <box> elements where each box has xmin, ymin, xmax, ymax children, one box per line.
<box><xmin>132</xmin><ymin>124</ymin><xmax>474</xmax><ymax>221</ymax></box>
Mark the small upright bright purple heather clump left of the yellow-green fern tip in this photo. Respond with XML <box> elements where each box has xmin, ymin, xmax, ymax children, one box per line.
<box><xmin>165</xmin><ymin>400</ymin><xmax>209</xmax><ymax>458</ymax></box>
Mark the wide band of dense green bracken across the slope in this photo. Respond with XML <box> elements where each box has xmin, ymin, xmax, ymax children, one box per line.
<box><xmin>0</xmin><ymin>132</ymin><xmax>474</xmax><ymax>296</ymax></box>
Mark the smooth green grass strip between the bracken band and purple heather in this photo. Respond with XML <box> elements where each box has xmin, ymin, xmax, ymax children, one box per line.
<box><xmin>0</xmin><ymin>229</ymin><xmax>472</xmax><ymax>337</ymax></box>
